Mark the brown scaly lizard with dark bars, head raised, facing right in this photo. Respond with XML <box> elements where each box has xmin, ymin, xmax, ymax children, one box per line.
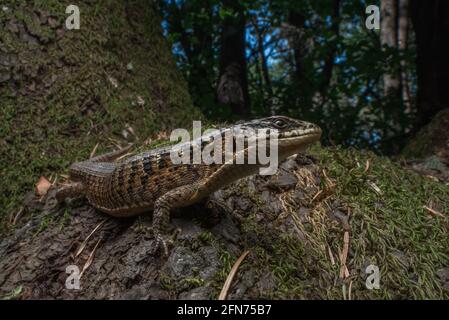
<box><xmin>56</xmin><ymin>116</ymin><xmax>322</xmax><ymax>255</ymax></box>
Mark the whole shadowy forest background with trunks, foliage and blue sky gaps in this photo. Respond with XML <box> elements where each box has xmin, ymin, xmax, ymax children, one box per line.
<box><xmin>159</xmin><ymin>0</ymin><xmax>449</xmax><ymax>155</ymax></box>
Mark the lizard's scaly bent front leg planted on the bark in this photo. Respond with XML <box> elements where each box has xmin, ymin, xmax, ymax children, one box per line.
<box><xmin>152</xmin><ymin>185</ymin><xmax>197</xmax><ymax>256</ymax></box>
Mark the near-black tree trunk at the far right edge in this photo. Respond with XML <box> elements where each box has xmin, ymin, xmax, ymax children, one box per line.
<box><xmin>411</xmin><ymin>0</ymin><xmax>449</xmax><ymax>130</ymax></box>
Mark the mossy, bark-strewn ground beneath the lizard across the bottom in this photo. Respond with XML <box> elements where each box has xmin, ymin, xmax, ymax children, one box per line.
<box><xmin>0</xmin><ymin>145</ymin><xmax>449</xmax><ymax>299</ymax></box>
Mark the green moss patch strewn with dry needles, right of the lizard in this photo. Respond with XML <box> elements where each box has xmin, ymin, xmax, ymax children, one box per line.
<box><xmin>217</xmin><ymin>146</ymin><xmax>449</xmax><ymax>299</ymax></box>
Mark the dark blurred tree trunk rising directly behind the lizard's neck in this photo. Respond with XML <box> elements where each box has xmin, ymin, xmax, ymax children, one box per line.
<box><xmin>217</xmin><ymin>0</ymin><xmax>250</xmax><ymax>116</ymax></box>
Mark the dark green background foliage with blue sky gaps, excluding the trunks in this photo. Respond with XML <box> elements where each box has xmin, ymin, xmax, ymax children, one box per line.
<box><xmin>161</xmin><ymin>0</ymin><xmax>416</xmax><ymax>154</ymax></box>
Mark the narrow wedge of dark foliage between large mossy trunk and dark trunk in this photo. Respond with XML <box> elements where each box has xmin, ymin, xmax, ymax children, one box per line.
<box><xmin>159</xmin><ymin>0</ymin><xmax>221</xmax><ymax>116</ymax></box>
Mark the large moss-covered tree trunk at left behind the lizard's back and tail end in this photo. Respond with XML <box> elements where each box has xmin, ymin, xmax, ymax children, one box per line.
<box><xmin>0</xmin><ymin>0</ymin><xmax>200</xmax><ymax>226</ymax></box>
